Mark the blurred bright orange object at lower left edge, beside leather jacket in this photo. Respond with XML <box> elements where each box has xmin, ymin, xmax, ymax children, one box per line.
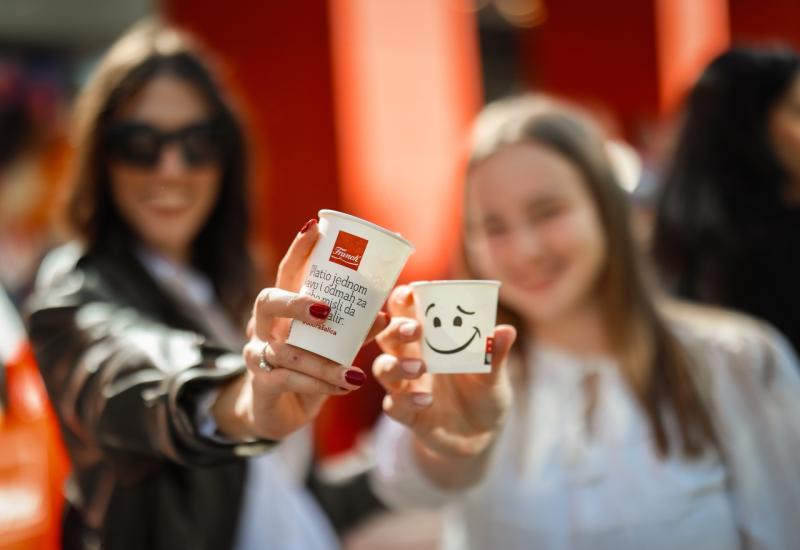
<box><xmin>0</xmin><ymin>344</ymin><xmax>69</xmax><ymax>550</ymax></box>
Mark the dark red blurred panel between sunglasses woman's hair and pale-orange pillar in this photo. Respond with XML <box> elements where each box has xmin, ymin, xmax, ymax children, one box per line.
<box><xmin>162</xmin><ymin>0</ymin><xmax>340</xmax><ymax>268</ymax></box>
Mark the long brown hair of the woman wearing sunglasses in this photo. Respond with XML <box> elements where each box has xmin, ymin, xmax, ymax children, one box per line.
<box><xmin>66</xmin><ymin>20</ymin><xmax>253</xmax><ymax>322</ymax></box>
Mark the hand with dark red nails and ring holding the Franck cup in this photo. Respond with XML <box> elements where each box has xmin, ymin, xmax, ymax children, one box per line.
<box><xmin>214</xmin><ymin>220</ymin><xmax>388</xmax><ymax>440</ymax></box>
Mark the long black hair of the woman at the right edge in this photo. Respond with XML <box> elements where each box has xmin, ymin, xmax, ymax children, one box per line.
<box><xmin>653</xmin><ymin>47</ymin><xmax>800</xmax><ymax>305</ymax></box>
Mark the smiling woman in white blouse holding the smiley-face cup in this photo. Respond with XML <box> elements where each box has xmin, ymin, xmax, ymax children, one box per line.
<box><xmin>372</xmin><ymin>100</ymin><xmax>800</xmax><ymax>550</ymax></box>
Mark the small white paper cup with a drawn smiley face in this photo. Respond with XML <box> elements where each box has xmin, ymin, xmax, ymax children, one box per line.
<box><xmin>411</xmin><ymin>280</ymin><xmax>500</xmax><ymax>373</ymax></box>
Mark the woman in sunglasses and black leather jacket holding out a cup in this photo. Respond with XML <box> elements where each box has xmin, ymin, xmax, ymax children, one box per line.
<box><xmin>29</xmin><ymin>22</ymin><xmax>385</xmax><ymax>550</ymax></box>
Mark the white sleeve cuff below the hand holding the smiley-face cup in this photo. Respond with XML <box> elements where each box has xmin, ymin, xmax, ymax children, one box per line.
<box><xmin>370</xmin><ymin>416</ymin><xmax>471</xmax><ymax>509</ymax></box>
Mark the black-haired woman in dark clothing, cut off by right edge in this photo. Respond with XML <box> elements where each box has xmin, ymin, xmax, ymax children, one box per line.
<box><xmin>653</xmin><ymin>48</ymin><xmax>800</xmax><ymax>350</ymax></box>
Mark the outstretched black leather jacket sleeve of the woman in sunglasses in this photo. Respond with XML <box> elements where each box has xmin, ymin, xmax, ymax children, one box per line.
<box><xmin>30</xmin><ymin>308</ymin><xmax>272</xmax><ymax>465</ymax></box>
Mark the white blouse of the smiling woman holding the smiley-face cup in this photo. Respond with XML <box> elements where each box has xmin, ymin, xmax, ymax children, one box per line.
<box><xmin>372</xmin><ymin>306</ymin><xmax>800</xmax><ymax>550</ymax></box>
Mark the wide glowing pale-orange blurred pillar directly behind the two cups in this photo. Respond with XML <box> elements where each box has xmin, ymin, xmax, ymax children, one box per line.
<box><xmin>330</xmin><ymin>0</ymin><xmax>480</xmax><ymax>280</ymax></box>
